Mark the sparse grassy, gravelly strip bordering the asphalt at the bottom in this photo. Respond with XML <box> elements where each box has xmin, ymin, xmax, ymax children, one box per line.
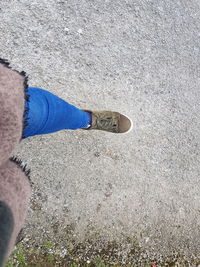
<box><xmin>6</xmin><ymin>241</ymin><xmax>200</xmax><ymax>267</ymax></box>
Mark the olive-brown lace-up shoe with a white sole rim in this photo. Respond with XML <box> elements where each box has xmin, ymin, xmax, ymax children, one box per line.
<box><xmin>84</xmin><ymin>110</ymin><xmax>133</xmax><ymax>133</ymax></box>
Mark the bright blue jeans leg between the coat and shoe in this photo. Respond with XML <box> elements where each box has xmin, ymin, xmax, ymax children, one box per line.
<box><xmin>23</xmin><ymin>87</ymin><xmax>91</xmax><ymax>138</ymax></box>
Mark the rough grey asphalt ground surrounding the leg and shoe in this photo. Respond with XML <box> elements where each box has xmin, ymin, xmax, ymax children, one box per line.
<box><xmin>0</xmin><ymin>0</ymin><xmax>200</xmax><ymax>266</ymax></box>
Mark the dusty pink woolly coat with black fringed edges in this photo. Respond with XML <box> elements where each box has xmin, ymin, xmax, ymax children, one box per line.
<box><xmin>0</xmin><ymin>59</ymin><xmax>31</xmax><ymax>266</ymax></box>
